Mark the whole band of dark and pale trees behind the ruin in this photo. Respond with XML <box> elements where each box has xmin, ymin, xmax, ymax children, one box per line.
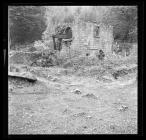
<box><xmin>9</xmin><ymin>6</ymin><xmax>137</xmax><ymax>47</ymax></box>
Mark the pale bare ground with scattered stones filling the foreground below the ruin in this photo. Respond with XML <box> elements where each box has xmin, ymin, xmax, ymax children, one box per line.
<box><xmin>8</xmin><ymin>67</ymin><xmax>137</xmax><ymax>134</ymax></box>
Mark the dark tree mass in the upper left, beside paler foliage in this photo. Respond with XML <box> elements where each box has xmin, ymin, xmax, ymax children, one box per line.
<box><xmin>9</xmin><ymin>6</ymin><xmax>46</xmax><ymax>46</ymax></box>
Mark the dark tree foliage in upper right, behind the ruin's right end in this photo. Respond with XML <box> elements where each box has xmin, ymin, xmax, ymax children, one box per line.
<box><xmin>102</xmin><ymin>6</ymin><xmax>137</xmax><ymax>42</ymax></box>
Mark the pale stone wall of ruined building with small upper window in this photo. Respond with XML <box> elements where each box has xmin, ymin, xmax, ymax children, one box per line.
<box><xmin>71</xmin><ymin>21</ymin><xmax>113</xmax><ymax>54</ymax></box>
